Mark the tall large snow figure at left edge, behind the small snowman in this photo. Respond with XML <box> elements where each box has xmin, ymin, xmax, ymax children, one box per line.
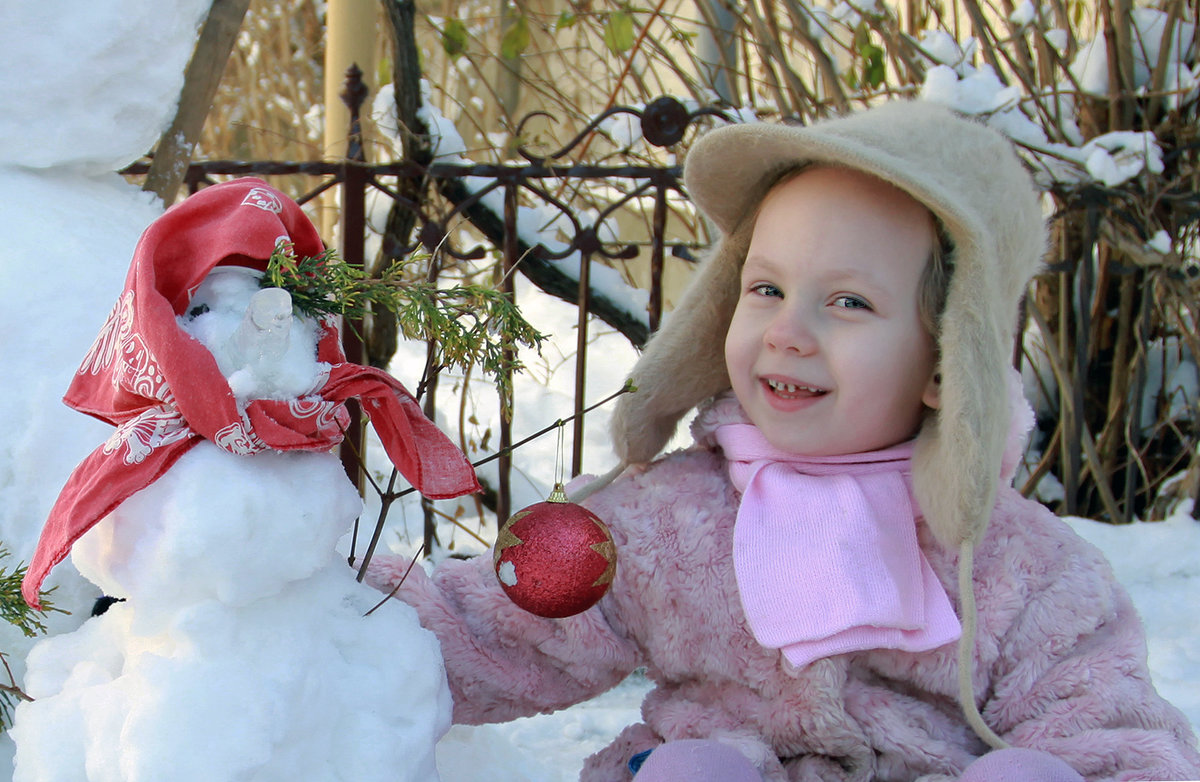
<box><xmin>0</xmin><ymin>0</ymin><xmax>210</xmax><ymax>719</ymax></box>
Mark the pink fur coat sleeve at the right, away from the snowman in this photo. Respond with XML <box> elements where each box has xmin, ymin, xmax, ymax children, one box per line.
<box><xmin>945</xmin><ymin>489</ymin><xmax>1200</xmax><ymax>781</ymax></box>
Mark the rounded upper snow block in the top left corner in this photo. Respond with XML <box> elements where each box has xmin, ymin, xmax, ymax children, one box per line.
<box><xmin>0</xmin><ymin>0</ymin><xmax>211</xmax><ymax>174</ymax></box>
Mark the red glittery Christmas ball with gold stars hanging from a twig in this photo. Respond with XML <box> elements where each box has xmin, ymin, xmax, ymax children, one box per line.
<box><xmin>492</xmin><ymin>483</ymin><xmax>617</xmax><ymax>619</ymax></box>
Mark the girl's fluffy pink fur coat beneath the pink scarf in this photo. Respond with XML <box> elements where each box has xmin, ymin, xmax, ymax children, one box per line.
<box><xmin>370</xmin><ymin>402</ymin><xmax>1200</xmax><ymax>782</ymax></box>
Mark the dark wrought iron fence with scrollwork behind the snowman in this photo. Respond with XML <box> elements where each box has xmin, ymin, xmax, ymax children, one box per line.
<box><xmin>122</xmin><ymin>67</ymin><xmax>727</xmax><ymax>540</ymax></box>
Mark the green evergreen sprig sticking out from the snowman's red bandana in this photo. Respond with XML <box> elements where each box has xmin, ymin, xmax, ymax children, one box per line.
<box><xmin>260</xmin><ymin>243</ymin><xmax>546</xmax><ymax>403</ymax></box>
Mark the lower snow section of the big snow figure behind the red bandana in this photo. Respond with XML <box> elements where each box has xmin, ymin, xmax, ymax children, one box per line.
<box><xmin>0</xmin><ymin>173</ymin><xmax>161</xmax><ymax>568</ymax></box>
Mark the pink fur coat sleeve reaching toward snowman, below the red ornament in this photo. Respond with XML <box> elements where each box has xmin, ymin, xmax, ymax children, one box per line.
<box><xmin>367</xmin><ymin>544</ymin><xmax>638</xmax><ymax>724</ymax></box>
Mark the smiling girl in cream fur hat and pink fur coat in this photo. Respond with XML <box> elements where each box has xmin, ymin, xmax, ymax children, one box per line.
<box><xmin>372</xmin><ymin>102</ymin><xmax>1200</xmax><ymax>782</ymax></box>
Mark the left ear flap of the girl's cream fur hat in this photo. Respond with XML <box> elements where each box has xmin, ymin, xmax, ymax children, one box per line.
<box><xmin>612</xmin><ymin>221</ymin><xmax>754</xmax><ymax>464</ymax></box>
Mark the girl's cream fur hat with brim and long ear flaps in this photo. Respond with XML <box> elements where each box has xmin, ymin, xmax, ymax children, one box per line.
<box><xmin>612</xmin><ymin>101</ymin><xmax>1045</xmax><ymax>556</ymax></box>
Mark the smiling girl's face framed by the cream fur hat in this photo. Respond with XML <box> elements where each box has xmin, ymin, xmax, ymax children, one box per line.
<box><xmin>725</xmin><ymin>167</ymin><xmax>937</xmax><ymax>456</ymax></box>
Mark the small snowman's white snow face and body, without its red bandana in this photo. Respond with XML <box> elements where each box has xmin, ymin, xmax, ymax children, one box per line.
<box><xmin>12</xmin><ymin>270</ymin><xmax>451</xmax><ymax>782</ymax></box>
